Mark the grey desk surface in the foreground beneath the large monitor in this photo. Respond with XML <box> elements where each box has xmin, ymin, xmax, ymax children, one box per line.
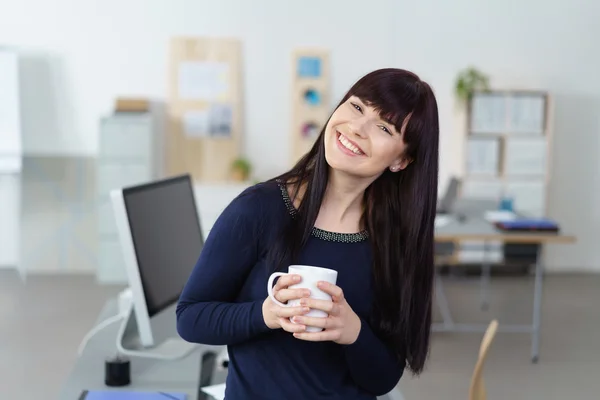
<box><xmin>59</xmin><ymin>300</ymin><xmax>403</xmax><ymax>400</ymax></box>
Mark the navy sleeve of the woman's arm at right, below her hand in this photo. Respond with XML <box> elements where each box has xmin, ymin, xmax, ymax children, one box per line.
<box><xmin>344</xmin><ymin>318</ymin><xmax>405</xmax><ymax>396</ymax></box>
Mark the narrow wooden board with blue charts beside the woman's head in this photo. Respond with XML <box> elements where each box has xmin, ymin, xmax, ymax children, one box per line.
<box><xmin>290</xmin><ymin>49</ymin><xmax>331</xmax><ymax>164</ymax></box>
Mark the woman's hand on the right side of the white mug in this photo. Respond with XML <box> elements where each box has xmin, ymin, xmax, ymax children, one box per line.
<box><xmin>293</xmin><ymin>282</ymin><xmax>361</xmax><ymax>344</ymax></box>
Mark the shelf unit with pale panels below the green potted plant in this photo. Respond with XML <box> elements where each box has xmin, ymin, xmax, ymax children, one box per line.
<box><xmin>461</xmin><ymin>90</ymin><xmax>552</xmax><ymax>217</ymax></box>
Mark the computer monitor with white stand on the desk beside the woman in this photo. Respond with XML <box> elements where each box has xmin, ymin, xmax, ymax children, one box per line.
<box><xmin>111</xmin><ymin>175</ymin><xmax>204</xmax><ymax>358</ymax></box>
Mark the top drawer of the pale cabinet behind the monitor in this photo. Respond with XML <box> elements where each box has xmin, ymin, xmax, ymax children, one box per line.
<box><xmin>100</xmin><ymin>119</ymin><xmax>153</xmax><ymax>159</ymax></box>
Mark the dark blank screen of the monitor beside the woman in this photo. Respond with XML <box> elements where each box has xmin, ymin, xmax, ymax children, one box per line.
<box><xmin>123</xmin><ymin>175</ymin><xmax>204</xmax><ymax>317</ymax></box>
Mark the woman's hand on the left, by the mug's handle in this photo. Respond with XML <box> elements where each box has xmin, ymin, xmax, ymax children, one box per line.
<box><xmin>262</xmin><ymin>274</ymin><xmax>310</xmax><ymax>333</ymax></box>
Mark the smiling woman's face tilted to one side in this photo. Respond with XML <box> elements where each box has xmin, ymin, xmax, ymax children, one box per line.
<box><xmin>324</xmin><ymin>96</ymin><xmax>410</xmax><ymax>178</ymax></box>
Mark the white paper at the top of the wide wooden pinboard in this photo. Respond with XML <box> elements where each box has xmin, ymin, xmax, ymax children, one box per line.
<box><xmin>177</xmin><ymin>61</ymin><xmax>230</xmax><ymax>102</ymax></box>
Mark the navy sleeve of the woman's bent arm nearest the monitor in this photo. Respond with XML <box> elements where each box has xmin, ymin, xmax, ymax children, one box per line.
<box><xmin>176</xmin><ymin>189</ymin><xmax>269</xmax><ymax>345</ymax></box>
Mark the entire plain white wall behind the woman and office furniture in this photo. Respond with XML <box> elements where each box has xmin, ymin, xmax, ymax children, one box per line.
<box><xmin>0</xmin><ymin>0</ymin><xmax>600</xmax><ymax>270</ymax></box>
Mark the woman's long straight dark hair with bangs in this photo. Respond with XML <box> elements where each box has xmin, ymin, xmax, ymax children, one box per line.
<box><xmin>270</xmin><ymin>69</ymin><xmax>439</xmax><ymax>375</ymax></box>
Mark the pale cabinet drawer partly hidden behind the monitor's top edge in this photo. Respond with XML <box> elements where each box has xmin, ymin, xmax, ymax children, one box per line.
<box><xmin>97</xmin><ymin>163</ymin><xmax>152</xmax><ymax>198</ymax></box>
